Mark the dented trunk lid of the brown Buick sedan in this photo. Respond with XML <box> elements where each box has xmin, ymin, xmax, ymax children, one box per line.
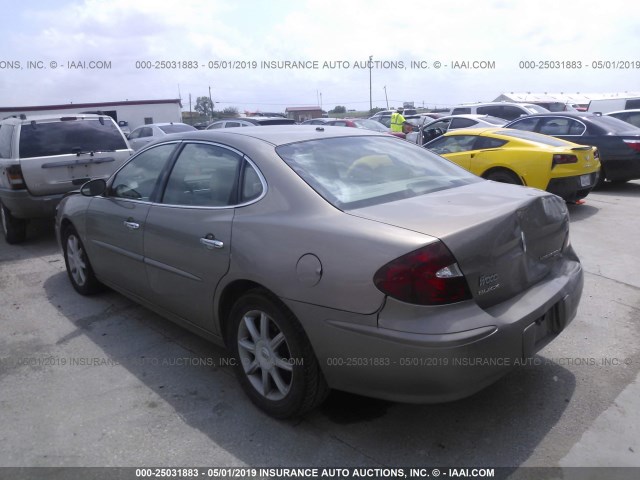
<box><xmin>348</xmin><ymin>182</ymin><xmax>569</xmax><ymax>308</ymax></box>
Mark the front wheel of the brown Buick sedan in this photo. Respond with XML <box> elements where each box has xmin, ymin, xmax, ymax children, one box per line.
<box><xmin>62</xmin><ymin>227</ymin><xmax>102</xmax><ymax>295</ymax></box>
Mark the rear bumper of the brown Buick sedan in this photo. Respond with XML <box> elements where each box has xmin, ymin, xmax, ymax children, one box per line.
<box><xmin>287</xmin><ymin>260</ymin><xmax>583</xmax><ymax>403</ymax></box>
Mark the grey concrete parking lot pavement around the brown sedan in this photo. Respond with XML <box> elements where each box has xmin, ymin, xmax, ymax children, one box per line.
<box><xmin>0</xmin><ymin>182</ymin><xmax>640</xmax><ymax>467</ymax></box>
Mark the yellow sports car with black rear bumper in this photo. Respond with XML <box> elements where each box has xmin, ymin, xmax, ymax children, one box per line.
<box><xmin>425</xmin><ymin>128</ymin><xmax>600</xmax><ymax>202</ymax></box>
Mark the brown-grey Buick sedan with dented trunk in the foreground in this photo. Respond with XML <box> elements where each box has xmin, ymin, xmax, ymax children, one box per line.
<box><xmin>56</xmin><ymin>125</ymin><xmax>583</xmax><ymax>417</ymax></box>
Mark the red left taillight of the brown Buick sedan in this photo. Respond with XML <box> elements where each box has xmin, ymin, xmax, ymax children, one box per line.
<box><xmin>373</xmin><ymin>241</ymin><xmax>471</xmax><ymax>305</ymax></box>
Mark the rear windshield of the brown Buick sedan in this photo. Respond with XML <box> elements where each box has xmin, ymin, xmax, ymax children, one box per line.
<box><xmin>276</xmin><ymin>136</ymin><xmax>482</xmax><ymax>210</ymax></box>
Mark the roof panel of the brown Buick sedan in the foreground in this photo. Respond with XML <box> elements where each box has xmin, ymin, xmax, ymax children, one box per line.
<box><xmin>156</xmin><ymin>124</ymin><xmax>384</xmax><ymax>146</ymax></box>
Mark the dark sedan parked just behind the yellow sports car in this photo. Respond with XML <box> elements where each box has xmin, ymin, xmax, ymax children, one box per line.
<box><xmin>505</xmin><ymin>112</ymin><xmax>640</xmax><ymax>182</ymax></box>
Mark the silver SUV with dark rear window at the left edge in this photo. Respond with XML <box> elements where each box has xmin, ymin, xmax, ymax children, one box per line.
<box><xmin>0</xmin><ymin>114</ymin><xmax>133</xmax><ymax>243</ymax></box>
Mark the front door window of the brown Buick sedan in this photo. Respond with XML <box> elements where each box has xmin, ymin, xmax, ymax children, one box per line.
<box><xmin>109</xmin><ymin>144</ymin><xmax>176</xmax><ymax>201</ymax></box>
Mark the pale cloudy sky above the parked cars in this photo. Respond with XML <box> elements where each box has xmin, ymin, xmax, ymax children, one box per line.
<box><xmin>0</xmin><ymin>0</ymin><xmax>640</xmax><ymax>111</ymax></box>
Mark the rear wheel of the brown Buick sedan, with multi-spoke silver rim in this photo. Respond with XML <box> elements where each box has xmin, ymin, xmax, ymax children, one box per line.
<box><xmin>228</xmin><ymin>289</ymin><xmax>328</xmax><ymax>418</ymax></box>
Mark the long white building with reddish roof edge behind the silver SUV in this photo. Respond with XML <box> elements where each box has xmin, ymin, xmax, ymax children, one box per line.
<box><xmin>0</xmin><ymin>99</ymin><xmax>182</xmax><ymax>130</ymax></box>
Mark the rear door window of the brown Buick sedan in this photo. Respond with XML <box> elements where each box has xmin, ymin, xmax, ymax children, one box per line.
<box><xmin>162</xmin><ymin>143</ymin><xmax>242</xmax><ymax>207</ymax></box>
